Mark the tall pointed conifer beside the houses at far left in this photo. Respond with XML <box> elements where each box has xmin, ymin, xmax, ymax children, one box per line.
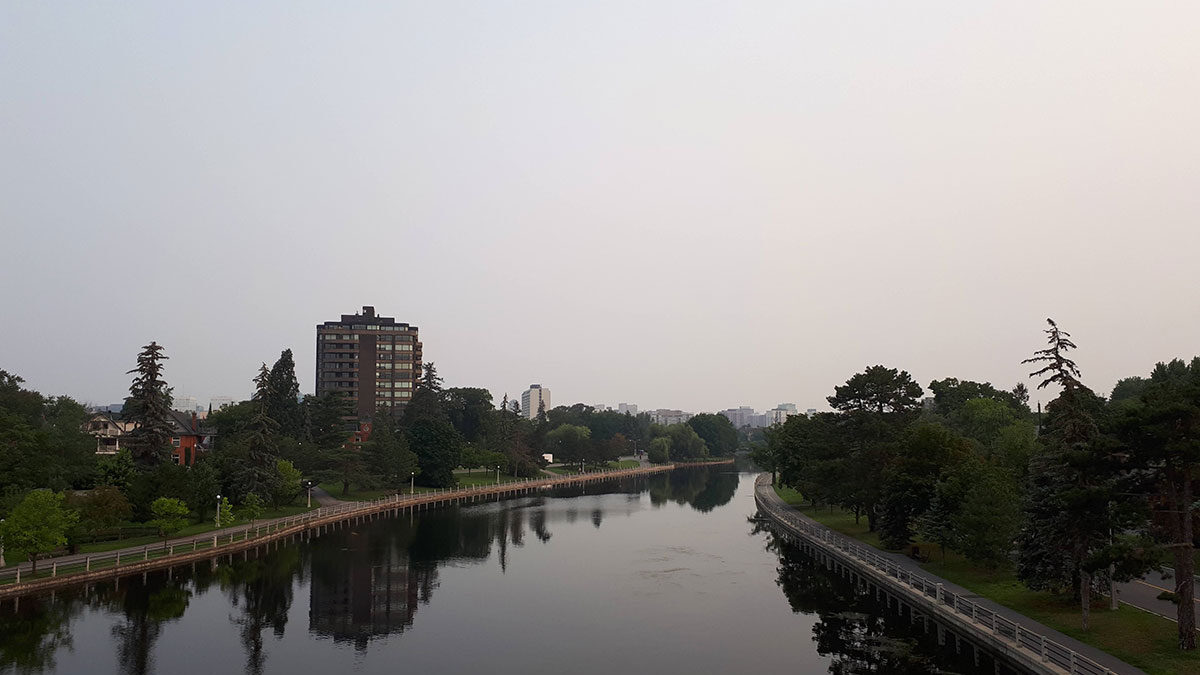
<box><xmin>124</xmin><ymin>342</ymin><xmax>172</xmax><ymax>468</ymax></box>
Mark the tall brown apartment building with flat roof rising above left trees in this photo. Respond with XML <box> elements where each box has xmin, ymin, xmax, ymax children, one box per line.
<box><xmin>317</xmin><ymin>306</ymin><xmax>421</xmax><ymax>418</ymax></box>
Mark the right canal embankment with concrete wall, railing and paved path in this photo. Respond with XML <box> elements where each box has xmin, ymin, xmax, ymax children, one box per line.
<box><xmin>755</xmin><ymin>474</ymin><xmax>1141</xmax><ymax>675</ymax></box>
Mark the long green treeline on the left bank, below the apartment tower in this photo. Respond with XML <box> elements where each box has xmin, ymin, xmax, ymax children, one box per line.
<box><xmin>0</xmin><ymin>342</ymin><xmax>738</xmax><ymax>564</ymax></box>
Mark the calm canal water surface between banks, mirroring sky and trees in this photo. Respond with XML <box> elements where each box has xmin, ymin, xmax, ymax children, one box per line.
<box><xmin>0</xmin><ymin>467</ymin><xmax>984</xmax><ymax>675</ymax></box>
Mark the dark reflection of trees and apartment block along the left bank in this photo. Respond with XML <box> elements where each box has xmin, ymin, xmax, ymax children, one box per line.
<box><xmin>0</xmin><ymin>467</ymin><xmax>739</xmax><ymax>675</ymax></box>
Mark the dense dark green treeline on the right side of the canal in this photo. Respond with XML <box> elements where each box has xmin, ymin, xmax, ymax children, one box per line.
<box><xmin>755</xmin><ymin>321</ymin><xmax>1200</xmax><ymax>650</ymax></box>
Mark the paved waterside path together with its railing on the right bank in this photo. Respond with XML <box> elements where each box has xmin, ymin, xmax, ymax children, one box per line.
<box><xmin>755</xmin><ymin>473</ymin><xmax>1142</xmax><ymax>675</ymax></box>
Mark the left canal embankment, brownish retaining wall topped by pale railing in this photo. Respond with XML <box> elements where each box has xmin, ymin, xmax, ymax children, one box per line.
<box><xmin>0</xmin><ymin>460</ymin><xmax>733</xmax><ymax>598</ymax></box>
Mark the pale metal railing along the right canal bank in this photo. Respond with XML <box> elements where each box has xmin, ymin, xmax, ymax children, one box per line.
<box><xmin>755</xmin><ymin>476</ymin><xmax>1115</xmax><ymax>675</ymax></box>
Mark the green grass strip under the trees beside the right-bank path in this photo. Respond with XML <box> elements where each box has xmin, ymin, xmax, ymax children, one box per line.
<box><xmin>775</xmin><ymin>488</ymin><xmax>1200</xmax><ymax>675</ymax></box>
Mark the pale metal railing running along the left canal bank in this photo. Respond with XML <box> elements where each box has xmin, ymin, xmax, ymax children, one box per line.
<box><xmin>0</xmin><ymin>462</ymin><xmax>703</xmax><ymax>586</ymax></box>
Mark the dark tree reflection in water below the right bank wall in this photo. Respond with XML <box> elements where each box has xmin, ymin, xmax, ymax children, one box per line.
<box><xmin>755</xmin><ymin>525</ymin><xmax>946</xmax><ymax>675</ymax></box>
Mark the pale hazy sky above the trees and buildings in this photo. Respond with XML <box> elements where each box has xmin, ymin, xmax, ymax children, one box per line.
<box><xmin>0</xmin><ymin>0</ymin><xmax>1200</xmax><ymax>411</ymax></box>
